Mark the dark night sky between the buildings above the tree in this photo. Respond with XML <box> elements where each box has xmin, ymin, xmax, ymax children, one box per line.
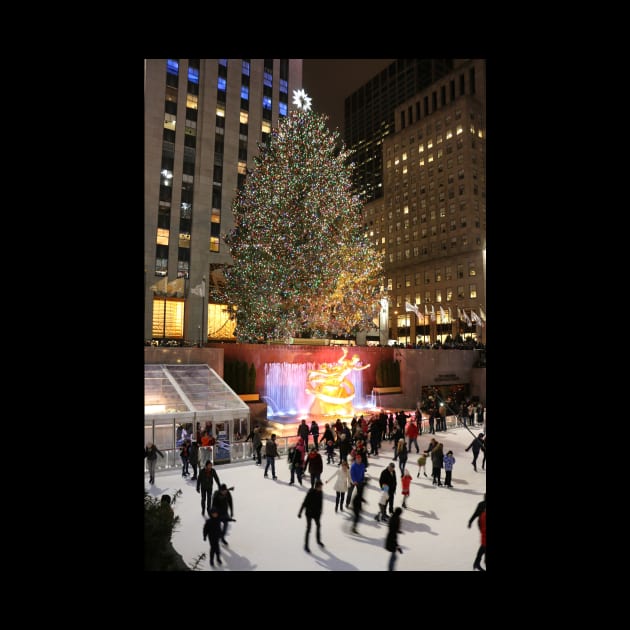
<box><xmin>302</xmin><ymin>59</ymin><xmax>395</xmax><ymax>137</ymax></box>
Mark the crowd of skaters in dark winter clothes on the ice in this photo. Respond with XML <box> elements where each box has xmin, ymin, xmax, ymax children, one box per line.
<box><xmin>145</xmin><ymin>400</ymin><xmax>486</xmax><ymax>571</ymax></box>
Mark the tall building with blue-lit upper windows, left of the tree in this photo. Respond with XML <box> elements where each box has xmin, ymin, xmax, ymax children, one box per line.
<box><xmin>144</xmin><ymin>59</ymin><xmax>302</xmax><ymax>344</ymax></box>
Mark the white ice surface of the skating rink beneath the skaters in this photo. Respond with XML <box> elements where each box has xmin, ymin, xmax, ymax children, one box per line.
<box><xmin>145</xmin><ymin>427</ymin><xmax>486</xmax><ymax>571</ymax></box>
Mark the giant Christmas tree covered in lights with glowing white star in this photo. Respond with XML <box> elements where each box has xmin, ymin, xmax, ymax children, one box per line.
<box><xmin>224</xmin><ymin>90</ymin><xmax>382</xmax><ymax>342</ymax></box>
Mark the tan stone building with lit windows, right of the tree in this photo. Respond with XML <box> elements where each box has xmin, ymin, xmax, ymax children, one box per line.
<box><xmin>364</xmin><ymin>59</ymin><xmax>486</xmax><ymax>344</ymax></box>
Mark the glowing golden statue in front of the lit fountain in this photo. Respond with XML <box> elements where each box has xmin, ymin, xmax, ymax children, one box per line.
<box><xmin>306</xmin><ymin>348</ymin><xmax>370</xmax><ymax>416</ymax></box>
